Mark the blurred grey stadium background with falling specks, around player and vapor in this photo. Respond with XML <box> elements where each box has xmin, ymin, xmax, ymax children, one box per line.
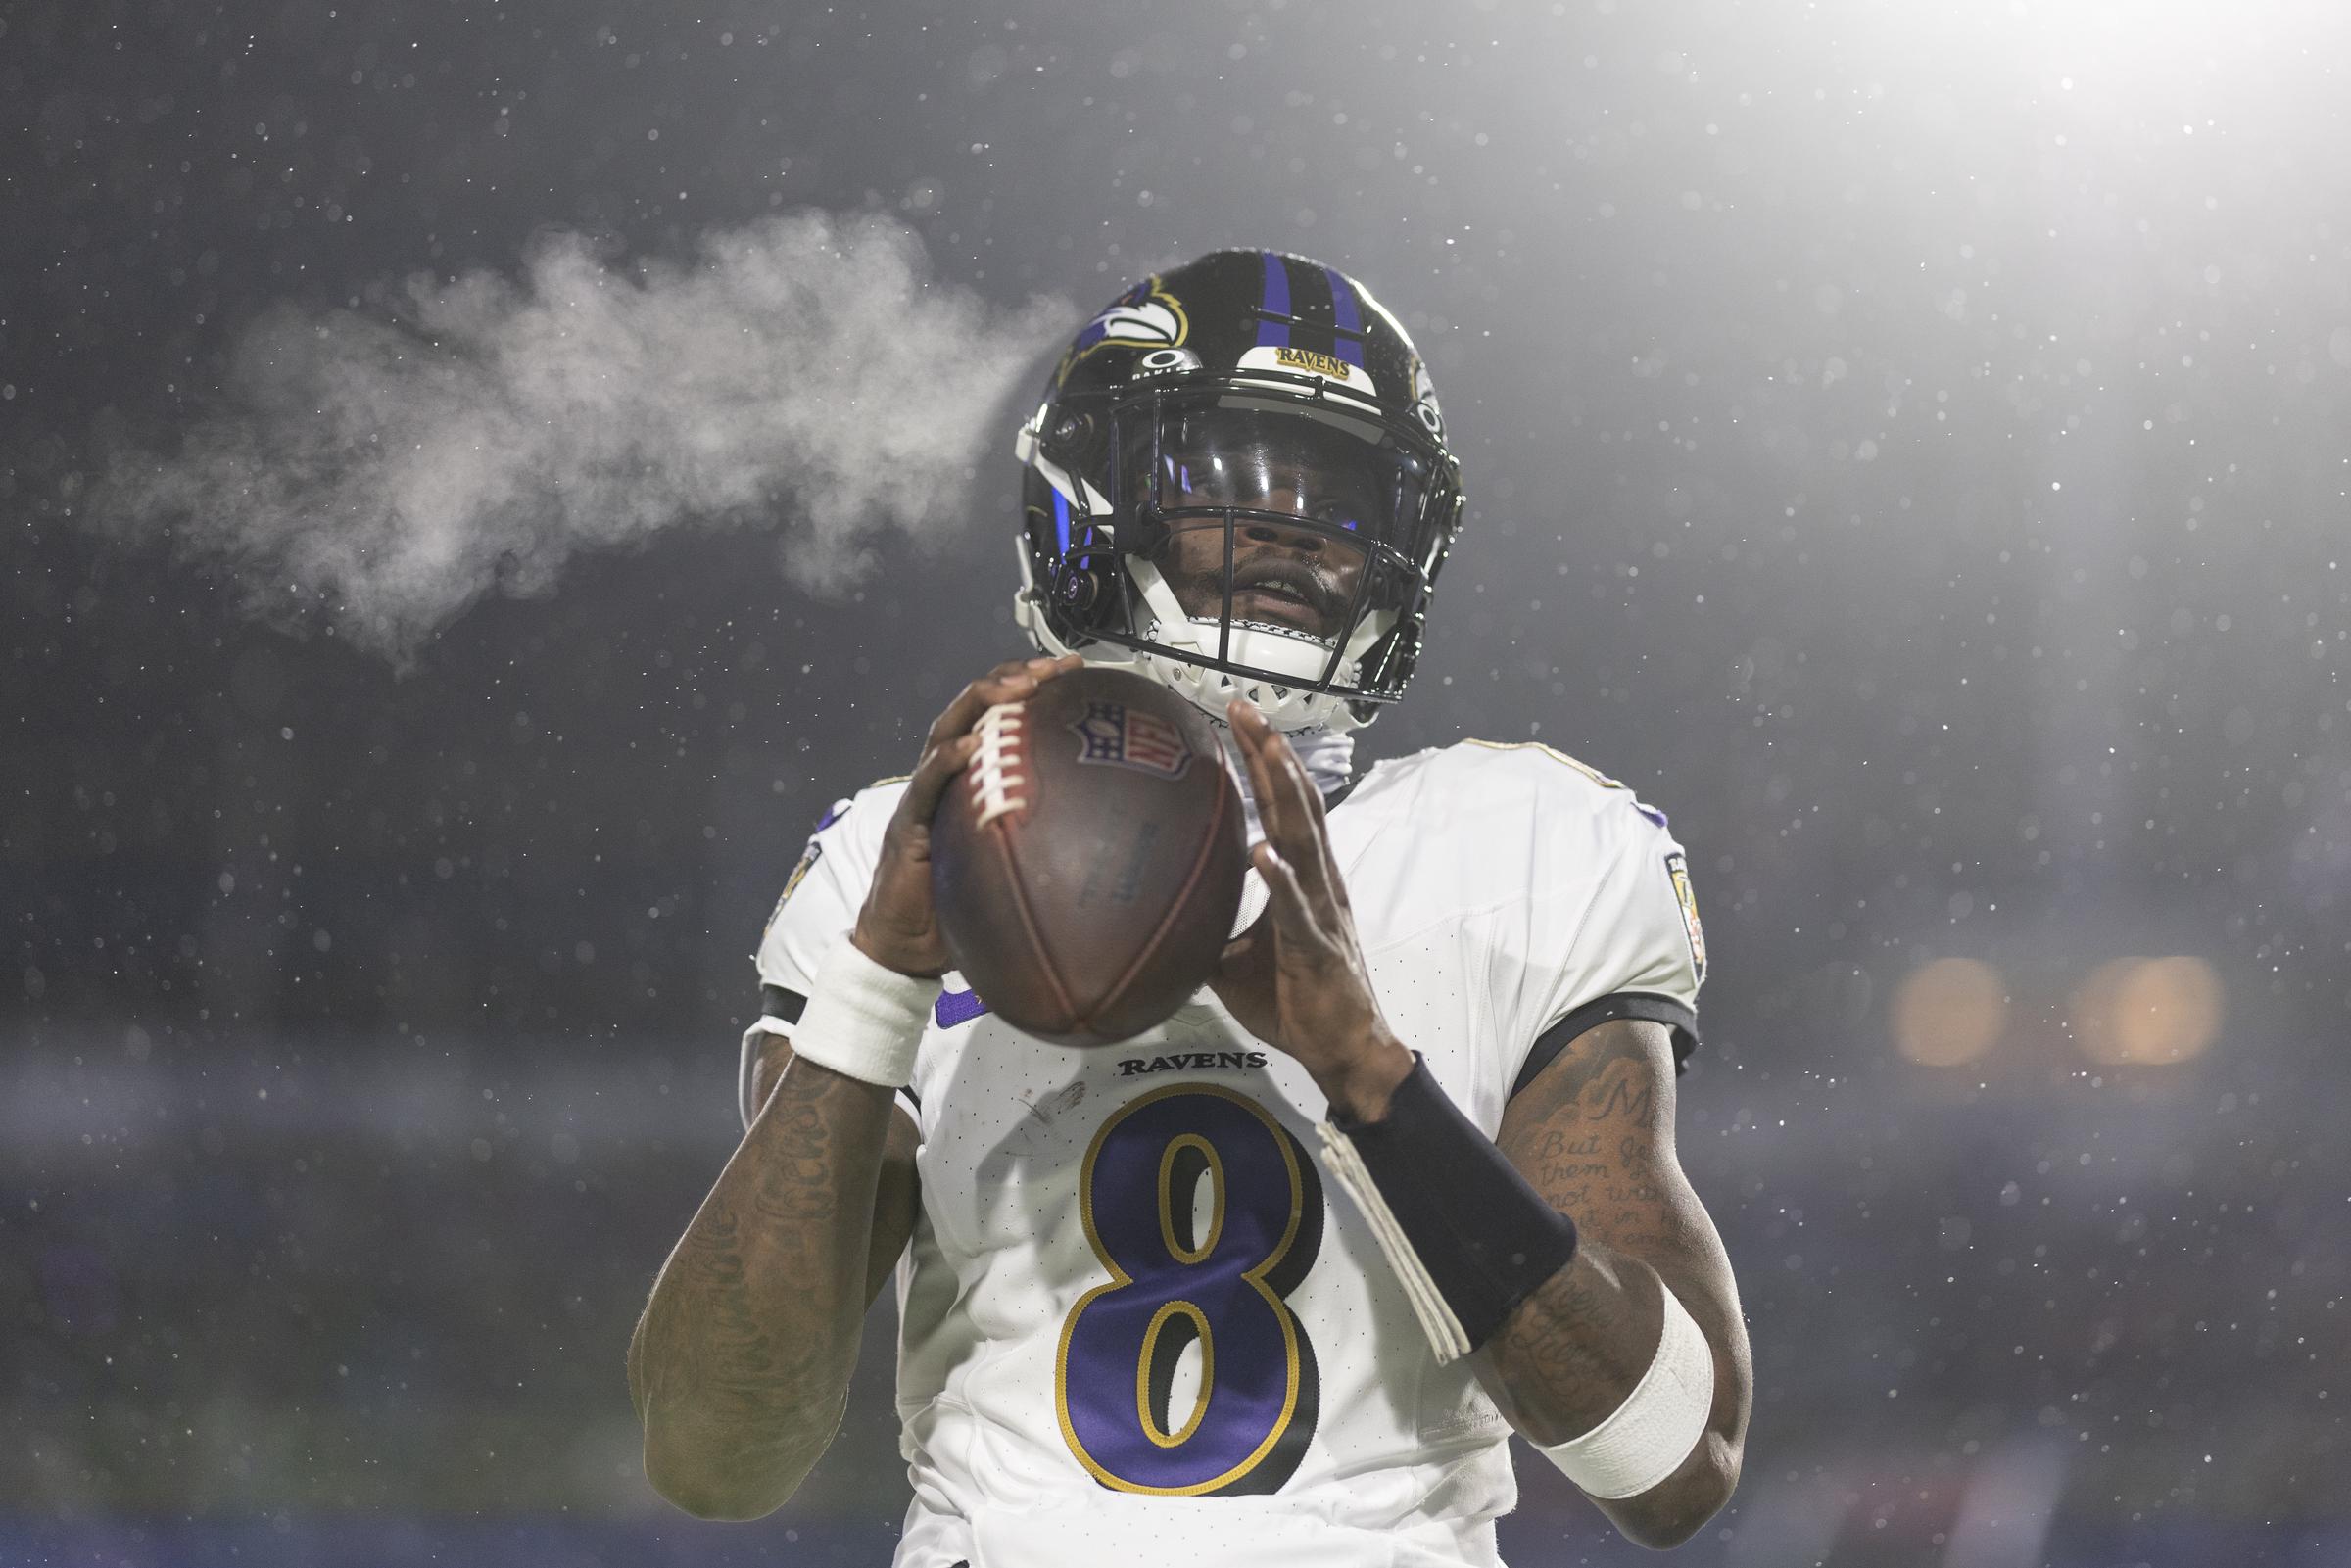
<box><xmin>0</xmin><ymin>0</ymin><xmax>2351</xmax><ymax>1568</ymax></box>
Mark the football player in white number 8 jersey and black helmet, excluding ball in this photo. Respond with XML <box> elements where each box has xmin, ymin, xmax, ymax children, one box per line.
<box><xmin>630</xmin><ymin>252</ymin><xmax>1750</xmax><ymax>1568</ymax></box>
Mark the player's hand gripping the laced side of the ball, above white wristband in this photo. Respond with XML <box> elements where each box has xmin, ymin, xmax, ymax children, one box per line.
<box><xmin>848</xmin><ymin>653</ymin><xmax>1083</xmax><ymax>978</ymax></box>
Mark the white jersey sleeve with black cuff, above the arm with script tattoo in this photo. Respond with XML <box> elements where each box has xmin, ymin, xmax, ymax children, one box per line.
<box><xmin>1511</xmin><ymin>785</ymin><xmax>1706</xmax><ymax>1093</ymax></box>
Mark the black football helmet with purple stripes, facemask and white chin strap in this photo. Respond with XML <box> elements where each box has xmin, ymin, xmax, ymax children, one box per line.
<box><xmin>1013</xmin><ymin>252</ymin><xmax>1463</xmax><ymax>731</ymax></box>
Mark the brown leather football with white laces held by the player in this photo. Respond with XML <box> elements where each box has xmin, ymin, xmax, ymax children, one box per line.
<box><xmin>931</xmin><ymin>670</ymin><xmax>1248</xmax><ymax>1046</ymax></box>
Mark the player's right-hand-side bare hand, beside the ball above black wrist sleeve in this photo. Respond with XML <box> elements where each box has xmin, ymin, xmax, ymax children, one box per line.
<box><xmin>1211</xmin><ymin>700</ymin><xmax>1413</xmax><ymax>1121</ymax></box>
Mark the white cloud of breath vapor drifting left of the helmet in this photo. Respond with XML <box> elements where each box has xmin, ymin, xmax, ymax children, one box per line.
<box><xmin>92</xmin><ymin>212</ymin><xmax>1072</xmax><ymax>660</ymax></box>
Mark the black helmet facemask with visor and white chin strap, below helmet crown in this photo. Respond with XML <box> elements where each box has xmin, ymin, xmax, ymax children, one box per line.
<box><xmin>1021</xmin><ymin>369</ymin><xmax>1460</xmax><ymax>731</ymax></box>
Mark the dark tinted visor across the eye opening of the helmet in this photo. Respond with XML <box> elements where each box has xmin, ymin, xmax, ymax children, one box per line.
<box><xmin>1119</xmin><ymin>393</ymin><xmax>1432</xmax><ymax>559</ymax></box>
